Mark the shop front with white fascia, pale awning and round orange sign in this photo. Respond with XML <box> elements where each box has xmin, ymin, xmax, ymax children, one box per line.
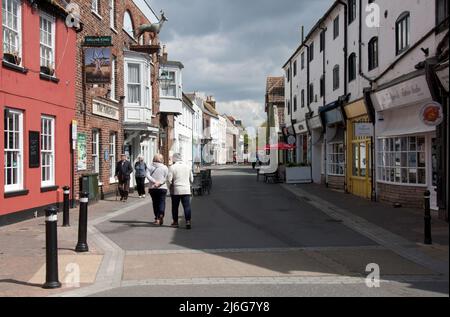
<box><xmin>372</xmin><ymin>71</ymin><xmax>443</xmax><ymax>210</ymax></box>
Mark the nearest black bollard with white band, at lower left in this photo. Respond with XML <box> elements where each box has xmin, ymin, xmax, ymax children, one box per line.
<box><xmin>43</xmin><ymin>206</ymin><xmax>61</xmax><ymax>289</ymax></box>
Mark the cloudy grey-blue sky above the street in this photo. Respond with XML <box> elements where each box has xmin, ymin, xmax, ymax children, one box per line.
<box><xmin>141</xmin><ymin>0</ymin><xmax>332</xmax><ymax>126</ymax></box>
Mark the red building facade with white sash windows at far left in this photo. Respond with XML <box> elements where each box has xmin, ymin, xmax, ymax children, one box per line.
<box><xmin>0</xmin><ymin>0</ymin><xmax>77</xmax><ymax>225</ymax></box>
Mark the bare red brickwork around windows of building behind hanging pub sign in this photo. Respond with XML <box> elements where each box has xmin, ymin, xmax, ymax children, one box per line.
<box><xmin>74</xmin><ymin>0</ymin><xmax>159</xmax><ymax>199</ymax></box>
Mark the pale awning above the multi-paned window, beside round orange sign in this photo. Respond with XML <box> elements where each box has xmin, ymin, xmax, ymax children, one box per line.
<box><xmin>376</xmin><ymin>104</ymin><xmax>436</xmax><ymax>137</ymax></box>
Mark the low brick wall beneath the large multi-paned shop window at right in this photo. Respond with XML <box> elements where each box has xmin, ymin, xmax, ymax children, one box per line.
<box><xmin>378</xmin><ymin>183</ymin><xmax>427</xmax><ymax>209</ymax></box>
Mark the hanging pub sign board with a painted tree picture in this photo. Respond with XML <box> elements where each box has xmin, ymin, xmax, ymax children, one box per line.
<box><xmin>83</xmin><ymin>47</ymin><xmax>111</xmax><ymax>84</ymax></box>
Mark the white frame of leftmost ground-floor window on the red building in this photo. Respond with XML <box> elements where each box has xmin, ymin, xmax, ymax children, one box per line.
<box><xmin>3</xmin><ymin>108</ymin><xmax>25</xmax><ymax>193</ymax></box>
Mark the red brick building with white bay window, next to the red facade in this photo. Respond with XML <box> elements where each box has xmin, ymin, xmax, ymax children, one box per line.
<box><xmin>73</xmin><ymin>0</ymin><xmax>163</xmax><ymax>199</ymax></box>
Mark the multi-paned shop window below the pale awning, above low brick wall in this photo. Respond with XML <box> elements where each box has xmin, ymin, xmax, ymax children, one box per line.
<box><xmin>377</xmin><ymin>136</ymin><xmax>427</xmax><ymax>185</ymax></box>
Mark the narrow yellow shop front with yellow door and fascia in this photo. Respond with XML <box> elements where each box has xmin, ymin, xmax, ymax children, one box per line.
<box><xmin>344</xmin><ymin>100</ymin><xmax>374</xmax><ymax>199</ymax></box>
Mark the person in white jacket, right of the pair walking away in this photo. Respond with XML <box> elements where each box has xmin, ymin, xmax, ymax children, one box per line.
<box><xmin>167</xmin><ymin>153</ymin><xmax>194</xmax><ymax>229</ymax></box>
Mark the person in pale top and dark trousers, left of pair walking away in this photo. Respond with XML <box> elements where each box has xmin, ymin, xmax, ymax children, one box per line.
<box><xmin>147</xmin><ymin>154</ymin><xmax>169</xmax><ymax>226</ymax></box>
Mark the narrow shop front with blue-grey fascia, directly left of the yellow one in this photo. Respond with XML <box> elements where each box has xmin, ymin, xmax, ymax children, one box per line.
<box><xmin>319</xmin><ymin>101</ymin><xmax>345</xmax><ymax>190</ymax></box>
